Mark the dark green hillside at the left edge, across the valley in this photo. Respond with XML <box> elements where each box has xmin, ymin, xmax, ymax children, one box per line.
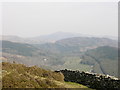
<box><xmin>0</xmin><ymin>41</ymin><xmax>37</xmax><ymax>56</ymax></box>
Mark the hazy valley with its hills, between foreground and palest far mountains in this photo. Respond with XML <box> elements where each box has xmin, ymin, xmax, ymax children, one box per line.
<box><xmin>0</xmin><ymin>33</ymin><xmax>118</xmax><ymax>76</ymax></box>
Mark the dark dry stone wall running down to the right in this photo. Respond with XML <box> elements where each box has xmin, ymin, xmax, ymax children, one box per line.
<box><xmin>56</xmin><ymin>69</ymin><xmax>120</xmax><ymax>90</ymax></box>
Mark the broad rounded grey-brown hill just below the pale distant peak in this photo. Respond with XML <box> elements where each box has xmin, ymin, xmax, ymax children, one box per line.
<box><xmin>56</xmin><ymin>37</ymin><xmax>118</xmax><ymax>50</ymax></box>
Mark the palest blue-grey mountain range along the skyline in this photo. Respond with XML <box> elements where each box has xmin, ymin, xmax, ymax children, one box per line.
<box><xmin>0</xmin><ymin>32</ymin><xmax>118</xmax><ymax>44</ymax></box>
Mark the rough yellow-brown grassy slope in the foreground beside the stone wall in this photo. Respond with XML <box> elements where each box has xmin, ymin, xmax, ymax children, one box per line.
<box><xmin>2</xmin><ymin>62</ymin><xmax>90</xmax><ymax>88</ymax></box>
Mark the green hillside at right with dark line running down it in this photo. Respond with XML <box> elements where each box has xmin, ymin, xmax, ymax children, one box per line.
<box><xmin>81</xmin><ymin>46</ymin><xmax>118</xmax><ymax>76</ymax></box>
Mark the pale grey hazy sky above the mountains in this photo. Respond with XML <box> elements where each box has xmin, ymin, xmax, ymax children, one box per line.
<box><xmin>2</xmin><ymin>2</ymin><xmax>118</xmax><ymax>37</ymax></box>
